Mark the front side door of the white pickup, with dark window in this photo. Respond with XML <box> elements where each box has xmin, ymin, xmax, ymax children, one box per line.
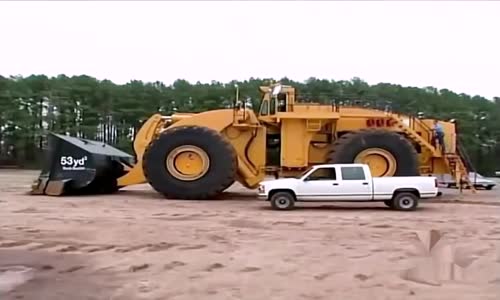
<box><xmin>297</xmin><ymin>167</ymin><xmax>339</xmax><ymax>201</ymax></box>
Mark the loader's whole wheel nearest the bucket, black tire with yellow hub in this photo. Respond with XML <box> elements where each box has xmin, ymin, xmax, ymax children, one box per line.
<box><xmin>143</xmin><ymin>126</ymin><xmax>238</xmax><ymax>200</ymax></box>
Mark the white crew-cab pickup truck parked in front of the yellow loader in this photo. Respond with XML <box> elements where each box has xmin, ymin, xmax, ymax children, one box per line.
<box><xmin>259</xmin><ymin>164</ymin><xmax>441</xmax><ymax>211</ymax></box>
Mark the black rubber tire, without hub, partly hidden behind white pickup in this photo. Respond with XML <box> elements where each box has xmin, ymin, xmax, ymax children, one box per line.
<box><xmin>327</xmin><ymin>128</ymin><xmax>420</xmax><ymax>176</ymax></box>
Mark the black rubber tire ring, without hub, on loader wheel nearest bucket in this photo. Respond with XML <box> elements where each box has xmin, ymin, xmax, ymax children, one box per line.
<box><xmin>143</xmin><ymin>126</ymin><xmax>238</xmax><ymax>200</ymax></box>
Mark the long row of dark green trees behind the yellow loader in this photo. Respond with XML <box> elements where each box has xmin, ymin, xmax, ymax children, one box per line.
<box><xmin>0</xmin><ymin>75</ymin><xmax>500</xmax><ymax>174</ymax></box>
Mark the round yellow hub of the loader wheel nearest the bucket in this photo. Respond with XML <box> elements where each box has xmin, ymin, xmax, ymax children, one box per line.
<box><xmin>166</xmin><ymin>145</ymin><xmax>210</xmax><ymax>181</ymax></box>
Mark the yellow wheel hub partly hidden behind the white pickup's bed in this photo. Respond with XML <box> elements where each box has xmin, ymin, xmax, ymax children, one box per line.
<box><xmin>354</xmin><ymin>148</ymin><xmax>397</xmax><ymax>177</ymax></box>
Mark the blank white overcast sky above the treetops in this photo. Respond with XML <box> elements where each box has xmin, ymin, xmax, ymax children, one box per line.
<box><xmin>0</xmin><ymin>1</ymin><xmax>500</xmax><ymax>99</ymax></box>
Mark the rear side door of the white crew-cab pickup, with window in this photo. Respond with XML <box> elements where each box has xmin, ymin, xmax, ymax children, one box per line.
<box><xmin>338</xmin><ymin>166</ymin><xmax>372</xmax><ymax>200</ymax></box>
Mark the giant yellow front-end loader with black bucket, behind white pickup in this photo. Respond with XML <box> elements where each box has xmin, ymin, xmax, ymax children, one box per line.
<box><xmin>32</xmin><ymin>84</ymin><xmax>476</xmax><ymax>199</ymax></box>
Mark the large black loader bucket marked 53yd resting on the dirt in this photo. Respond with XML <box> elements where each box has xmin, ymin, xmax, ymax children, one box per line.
<box><xmin>31</xmin><ymin>133</ymin><xmax>135</xmax><ymax>196</ymax></box>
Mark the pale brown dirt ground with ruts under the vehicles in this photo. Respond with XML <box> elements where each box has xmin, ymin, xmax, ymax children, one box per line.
<box><xmin>0</xmin><ymin>170</ymin><xmax>500</xmax><ymax>300</ymax></box>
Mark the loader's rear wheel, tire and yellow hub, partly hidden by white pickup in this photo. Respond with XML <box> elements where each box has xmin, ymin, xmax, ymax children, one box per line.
<box><xmin>328</xmin><ymin>128</ymin><xmax>420</xmax><ymax>177</ymax></box>
